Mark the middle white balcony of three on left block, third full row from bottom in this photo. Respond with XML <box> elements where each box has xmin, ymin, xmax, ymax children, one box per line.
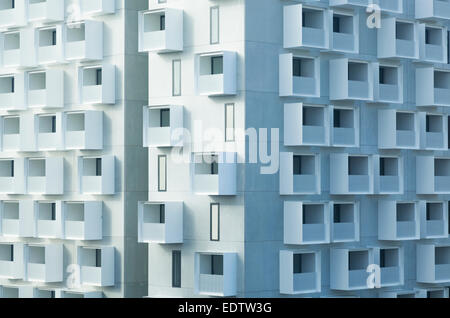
<box><xmin>27</xmin><ymin>157</ymin><xmax>64</xmax><ymax>195</ymax></box>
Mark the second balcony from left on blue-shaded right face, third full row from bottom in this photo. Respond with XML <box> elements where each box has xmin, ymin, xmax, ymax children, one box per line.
<box><xmin>330</xmin><ymin>153</ymin><xmax>374</xmax><ymax>195</ymax></box>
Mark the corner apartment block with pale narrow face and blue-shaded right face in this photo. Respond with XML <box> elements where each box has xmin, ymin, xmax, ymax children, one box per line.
<box><xmin>138</xmin><ymin>0</ymin><xmax>450</xmax><ymax>298</ymax></box>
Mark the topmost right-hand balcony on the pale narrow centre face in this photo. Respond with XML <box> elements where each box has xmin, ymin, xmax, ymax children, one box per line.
<box><xmin>197</xmin><ymin>51</ymin><xmax>237</xmax><ymax>96</ymax></box>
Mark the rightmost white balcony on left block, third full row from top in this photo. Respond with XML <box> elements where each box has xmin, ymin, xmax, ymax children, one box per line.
<box><xmin>63</xmin><ymin>110</ymin><xmax>103</xmax><ymax>150</ymax></box>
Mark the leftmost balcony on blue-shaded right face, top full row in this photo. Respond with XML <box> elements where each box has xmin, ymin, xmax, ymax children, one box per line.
<box><xmin>283</xmin><ymin>4</ymin><xmax>330</xmax><ymax>49</ymax></box>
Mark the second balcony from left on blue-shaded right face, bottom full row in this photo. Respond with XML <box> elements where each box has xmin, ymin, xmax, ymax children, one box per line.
<box><xmin>330</xmin><ymin>248</ymin><xmax>374</xmax><ymax>291</ymax></box>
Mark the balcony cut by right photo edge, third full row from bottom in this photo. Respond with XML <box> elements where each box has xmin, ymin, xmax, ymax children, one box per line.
<box><xmin>416</xmin><ymin>156</ymin><xmax>450</xmax><ymax>194</ymax></box>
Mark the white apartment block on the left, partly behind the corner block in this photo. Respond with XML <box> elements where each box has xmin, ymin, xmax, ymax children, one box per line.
<box><xmin>0</xmin><ymin>0</ymin><xmax>148</xmax><ymax>298</ymax></box>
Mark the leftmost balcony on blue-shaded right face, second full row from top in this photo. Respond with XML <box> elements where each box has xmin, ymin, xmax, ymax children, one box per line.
<box><xmin>279</xmin><ymin>53</ymin><xmax>320</xmax><ymax>97</ymax></box>
